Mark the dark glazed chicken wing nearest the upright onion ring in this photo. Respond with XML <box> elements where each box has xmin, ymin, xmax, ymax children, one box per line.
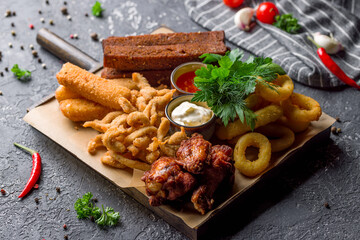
<box><xmin>191</xmin><ymin>145</ymin><xmax>235</xmax><ymax>214</ymax></box>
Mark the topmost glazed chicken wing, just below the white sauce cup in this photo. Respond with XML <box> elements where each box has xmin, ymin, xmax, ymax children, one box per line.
<box><xmin>176</xmin><ymin>133</ymin><xmax>211</xmax><ymax>174</ymax></box>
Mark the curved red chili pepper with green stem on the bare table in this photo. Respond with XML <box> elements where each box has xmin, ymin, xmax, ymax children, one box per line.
<box><xmin>14</xmin><ymin>143</ymin><xmax>41</xmax><ymax>198</ymax></box>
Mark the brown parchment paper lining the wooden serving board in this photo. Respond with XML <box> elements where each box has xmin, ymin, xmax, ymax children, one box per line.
<box><xmin>24</xmin><ymin>99</ymin><xmax>335</xmax><ymax>228</ymax></box>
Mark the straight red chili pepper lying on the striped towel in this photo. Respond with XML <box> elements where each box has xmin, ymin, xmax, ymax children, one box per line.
<box><xmin>308</xmin><ymin>37</ymin><xmax>360</xmax><ymax>90</ymax></box>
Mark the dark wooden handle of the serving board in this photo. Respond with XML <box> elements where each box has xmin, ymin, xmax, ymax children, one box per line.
<box><xmin>36</xmin><ymin>28</ymin><xmax>102</xmax><ymax>72</ymax></box>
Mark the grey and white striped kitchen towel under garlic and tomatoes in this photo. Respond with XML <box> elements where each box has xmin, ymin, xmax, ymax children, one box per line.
<box><xmin>185</xmin><ymin>0</ymin><xmax>360</xmax><ymax>88</ymax></box>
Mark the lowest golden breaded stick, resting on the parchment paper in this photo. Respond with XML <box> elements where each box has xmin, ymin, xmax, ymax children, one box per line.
<box><xmin>59</xmin><ymin>99</ymin><xmax>112</xmax><ymax>122</ymax></box>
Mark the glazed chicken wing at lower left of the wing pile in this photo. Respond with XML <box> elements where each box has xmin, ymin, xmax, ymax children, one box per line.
<box><xmin>141</xmin><ymin>157</ymin><xmax>195</xmax><ymax>206</ymax></box>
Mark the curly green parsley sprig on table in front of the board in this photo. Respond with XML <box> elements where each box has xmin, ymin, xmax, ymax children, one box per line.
<box><xmin>74</xmin><ymin>192</ymin><xmax>120</xmax><ymax>226</ymax></box>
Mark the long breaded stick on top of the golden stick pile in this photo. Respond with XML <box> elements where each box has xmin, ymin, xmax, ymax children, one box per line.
<box><xmin>56</xmin><ymin>63</ymin><xmax>131</xmax><ymax>110</ymax></box>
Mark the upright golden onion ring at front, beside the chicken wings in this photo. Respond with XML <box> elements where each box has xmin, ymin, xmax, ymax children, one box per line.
<box><xmin>234</xmin><ymin>133</ymin><xmax>271</xmax><ymax>177</ymax></box>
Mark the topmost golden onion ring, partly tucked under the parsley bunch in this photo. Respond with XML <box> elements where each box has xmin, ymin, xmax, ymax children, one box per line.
<box><xmin>255</xmin><ymin>75</ymin><xmax>294</xmax><ymax>102</ymax></box>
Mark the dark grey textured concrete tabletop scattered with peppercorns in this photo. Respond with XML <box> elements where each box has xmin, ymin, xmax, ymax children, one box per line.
<box><xmin>0</xmin><ymin>0</ymin><xmax>360</xmax><ymax>239</ymax></box>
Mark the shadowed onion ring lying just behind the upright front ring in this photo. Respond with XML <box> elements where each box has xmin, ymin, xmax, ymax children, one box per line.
<box><xmin>256</xmin><ymin>123</ymin><xmax>295</xmax><ymax>152</ymax></box>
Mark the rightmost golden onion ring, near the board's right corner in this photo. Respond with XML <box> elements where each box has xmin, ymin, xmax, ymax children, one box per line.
<box><xmin>281</xmin><ymin>93</ymin><xmax>322</xmax><ymax>122</ymax></box>
